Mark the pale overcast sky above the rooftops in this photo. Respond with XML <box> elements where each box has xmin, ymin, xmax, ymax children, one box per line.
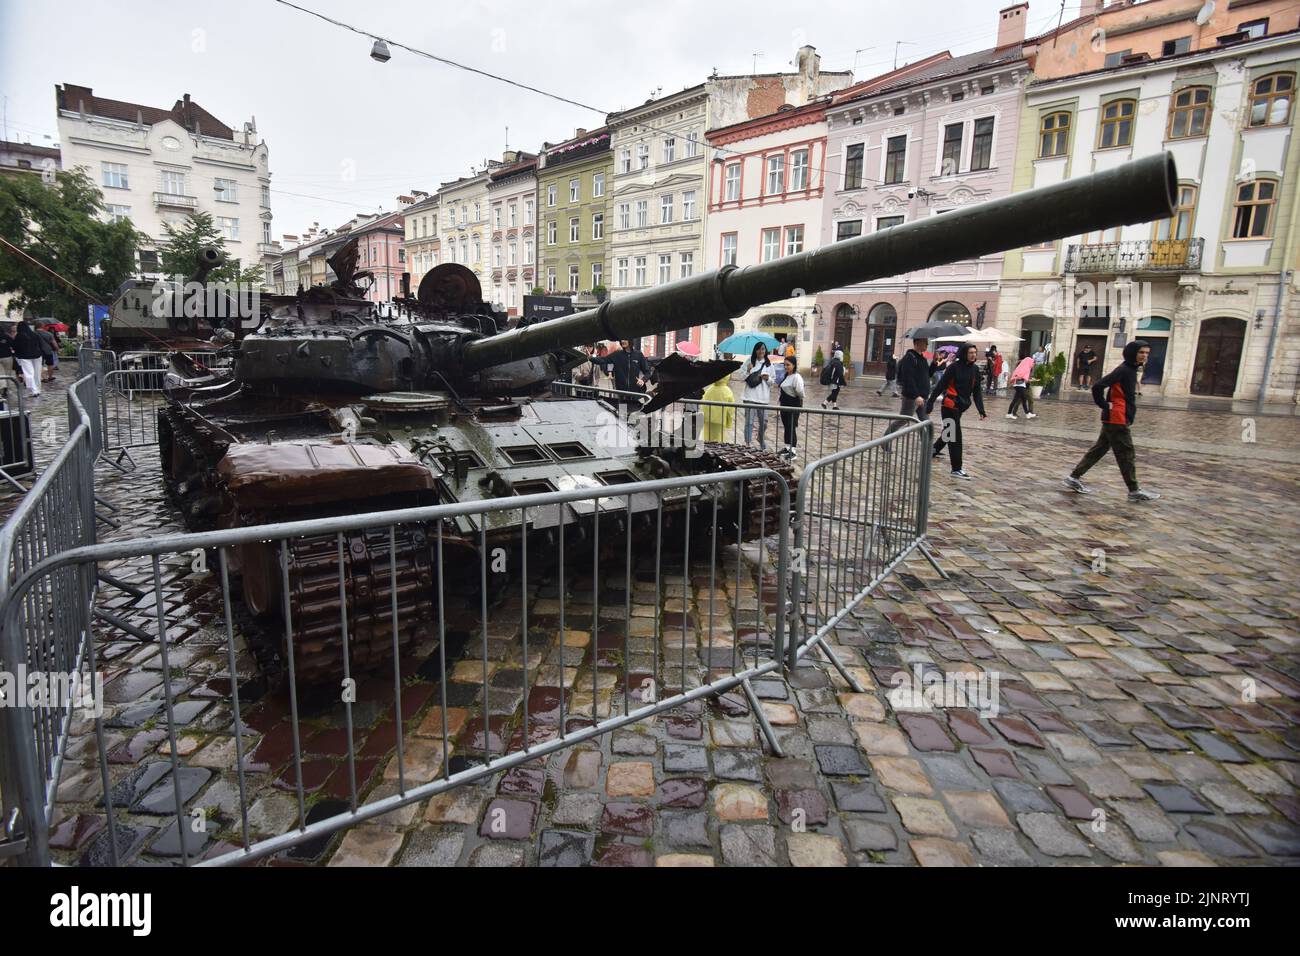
<box><xmin>0</xmin><ymin>0</ymin><xmax>1078</xmax><ymax>239</ymax></box>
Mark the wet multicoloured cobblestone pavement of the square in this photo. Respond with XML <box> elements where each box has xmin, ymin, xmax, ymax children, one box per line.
<box><xmin>8</xmin><ymin>374</ymin><xmax>1300</xmax><ymax>866</ymax></box>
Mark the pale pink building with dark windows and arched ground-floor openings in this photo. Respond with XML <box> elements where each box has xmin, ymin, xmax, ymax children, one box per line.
<box><xmin>816</xmin><ymin>4</ymin><xmax>1028</xmax><ymax>373</ymax></box>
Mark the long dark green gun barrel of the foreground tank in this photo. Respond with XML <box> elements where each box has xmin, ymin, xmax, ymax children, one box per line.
<box><xmin>463</xmin><ymin>152</ymin><xmax>1178</xmax><ymax>372</ymax></box>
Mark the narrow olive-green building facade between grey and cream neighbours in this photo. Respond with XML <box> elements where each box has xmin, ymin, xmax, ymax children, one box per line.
<box><xmin>537</xmin><ymin>127</ymin><xmax>614</xmax><ymax>295</ymax></box>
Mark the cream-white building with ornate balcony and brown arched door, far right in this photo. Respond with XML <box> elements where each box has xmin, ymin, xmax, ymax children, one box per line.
<box><xmin>1001</xmin><ymin>23</ymin><xmax>1300</xmax><ymax>401</ymax></box>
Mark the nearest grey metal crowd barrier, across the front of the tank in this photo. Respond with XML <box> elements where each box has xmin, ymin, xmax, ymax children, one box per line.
<box><xmin>0</xmin><ymin>465</ymin><xmax>790</xmax><ymax>865</ymax></box>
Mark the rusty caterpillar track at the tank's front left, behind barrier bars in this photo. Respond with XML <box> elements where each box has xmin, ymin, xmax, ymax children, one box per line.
<box><xmin>239</xmin><ymin>528</ymin><xmax>437</xmax><ymax>688</ymax></box>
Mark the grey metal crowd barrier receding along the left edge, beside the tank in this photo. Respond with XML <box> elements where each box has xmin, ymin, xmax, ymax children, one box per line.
<box><xmin>0</xmin><ymin>375</ymin><xmax>98</xmax><ymax>857</ymax></box>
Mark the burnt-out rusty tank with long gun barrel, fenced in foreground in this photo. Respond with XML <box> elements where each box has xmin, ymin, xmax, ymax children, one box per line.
<box><xmin>159</xmin><ymin>156</ymin><xmax>1177</xmax><ymax>685</ymax></box>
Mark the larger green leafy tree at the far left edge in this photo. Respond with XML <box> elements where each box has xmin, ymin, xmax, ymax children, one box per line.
<box><xmin>0</xmin><ymin>169</ymin><xmax>143</xmax><ymax>326</ymax></box>
